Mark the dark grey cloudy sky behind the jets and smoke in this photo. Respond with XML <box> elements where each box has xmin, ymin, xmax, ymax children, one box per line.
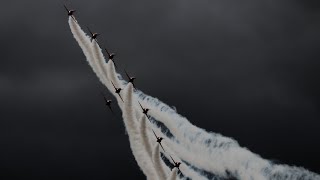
<box><xmin>0</xmin><ymin>0</ymin><xmax>320</xmax><ymax>179</ymax></box>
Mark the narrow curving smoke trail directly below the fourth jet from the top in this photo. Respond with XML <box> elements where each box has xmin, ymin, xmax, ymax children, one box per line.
<box><xmin>123</xmin><ymin>84</ymin><xmax>157</xmax><ymax>179</ymax></box>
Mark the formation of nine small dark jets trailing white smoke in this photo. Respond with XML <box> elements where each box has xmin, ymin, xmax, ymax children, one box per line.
<box><xmin>64</xmin><ymin>5</ymin><xmax>182</xmax><ymax>177</ymax></box>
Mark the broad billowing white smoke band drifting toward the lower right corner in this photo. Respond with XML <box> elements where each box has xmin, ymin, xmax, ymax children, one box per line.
<box><xmin>137</xmin><ymin>92</ymin><xmax>320</xmax><ymax>179</ymax></box>
